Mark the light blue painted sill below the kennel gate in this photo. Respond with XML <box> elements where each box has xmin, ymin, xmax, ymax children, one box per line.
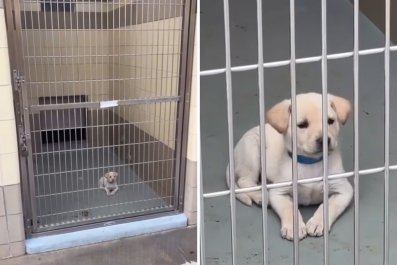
<box><xmin>26</xmin><ymin>211</ymin><xmax>187</xmax><ymax>254</ymax></box>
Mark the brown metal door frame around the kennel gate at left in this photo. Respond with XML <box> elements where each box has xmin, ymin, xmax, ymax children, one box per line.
<box><xmin>4</xmin><ymin>0</ymin><xmax>197</xmax><ymax>235</ymax></box>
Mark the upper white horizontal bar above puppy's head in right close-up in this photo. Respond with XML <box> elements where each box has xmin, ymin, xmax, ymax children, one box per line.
<box><xmin>200</xmin><ymin>45</ymin><xmax>397</xmax><ymax>76</ymax></box>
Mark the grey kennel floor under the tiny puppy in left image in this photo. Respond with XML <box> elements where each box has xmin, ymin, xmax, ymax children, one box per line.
<box><xmin>33</xmin><ymin>142</ymin><xmax>165</xmax><ymax>230</ymax></box>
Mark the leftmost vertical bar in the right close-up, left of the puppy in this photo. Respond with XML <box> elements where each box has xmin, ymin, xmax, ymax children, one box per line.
<box><xmin>223</xmin><ymin>0</ymin><xmax>237</xmax><ymax>265</ymax></box>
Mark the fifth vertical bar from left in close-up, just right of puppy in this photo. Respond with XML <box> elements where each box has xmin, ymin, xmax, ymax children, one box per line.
<box><xmin>353</xmin><ymin>0</ymin><xmax>360</xmax><ymax>265</ymax></box>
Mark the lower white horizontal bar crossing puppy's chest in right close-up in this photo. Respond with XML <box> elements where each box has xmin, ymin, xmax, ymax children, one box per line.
<box><xmin>203</xmin><ymin>165</ymin><xmax>397</xmax><ymax>198</ymax></box>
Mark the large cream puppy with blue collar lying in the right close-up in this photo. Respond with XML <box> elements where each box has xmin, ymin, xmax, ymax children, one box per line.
<box><xmin>226</xmin><ymin>93</ymin><xmax>353</xmax><ymax>240</ymax></box>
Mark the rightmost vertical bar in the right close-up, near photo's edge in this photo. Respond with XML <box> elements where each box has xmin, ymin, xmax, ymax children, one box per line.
<box><xmin>383</xmin><ymin>0</ymin><xmax>390</xmax><ymax>265</ymax></box>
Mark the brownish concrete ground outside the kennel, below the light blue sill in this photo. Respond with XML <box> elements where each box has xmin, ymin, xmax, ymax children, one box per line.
<box><xmin>0</xmin><ymin>228</ymin><xmax>197</xmax><ymax>265</ymax></box>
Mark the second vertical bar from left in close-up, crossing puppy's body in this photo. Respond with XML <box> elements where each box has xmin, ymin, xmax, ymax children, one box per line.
<box><xmin>256</xmin><ymin>0</ymin><xmax>269</xmax><ymax>264</ymax></box>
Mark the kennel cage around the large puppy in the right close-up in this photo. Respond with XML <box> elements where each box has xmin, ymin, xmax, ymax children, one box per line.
<box><xmin>200</xmin><ymin>0</ymin><xmax>397</xmax><ymax>265</ymax></box>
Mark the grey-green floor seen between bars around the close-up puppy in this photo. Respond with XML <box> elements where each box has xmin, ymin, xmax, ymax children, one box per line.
<box><xmin>200</xmin><ymin>0</ymin><xmax>397</xmax><ymax>265</ymax></box>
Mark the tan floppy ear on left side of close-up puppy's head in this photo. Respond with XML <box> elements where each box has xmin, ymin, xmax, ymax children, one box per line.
<box><xmin>266</xmin><ymin>99</ymin><xmax>291</xmax><ymax>134</ymax></box>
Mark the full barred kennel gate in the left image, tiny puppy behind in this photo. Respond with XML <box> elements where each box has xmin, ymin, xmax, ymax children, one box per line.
<box><xmin>5</xmin><ymin>0</ymin><xmax>189</xmax><ymax>234</ymax></box>
